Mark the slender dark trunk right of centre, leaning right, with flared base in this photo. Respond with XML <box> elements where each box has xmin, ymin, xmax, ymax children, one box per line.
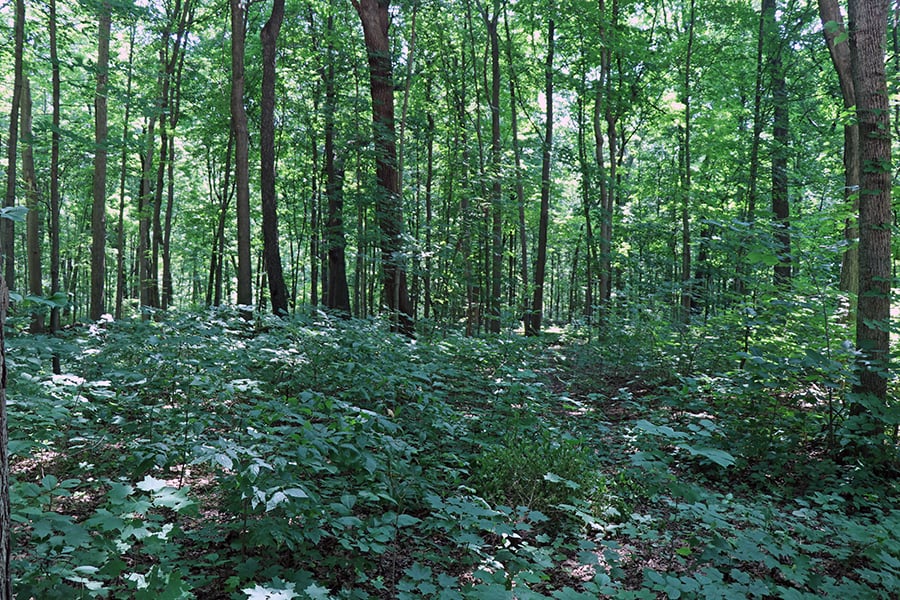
<box><xmin>525</xmin><ymin>11</ymin><xmax>556</xmax><ymax>335</ymax></box>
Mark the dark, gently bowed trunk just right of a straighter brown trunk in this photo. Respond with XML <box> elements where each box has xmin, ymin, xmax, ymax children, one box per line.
<box><xmin>259</xmin><ymin>0</ymin><xmax>288</xmax><ymax>316</ymax></box>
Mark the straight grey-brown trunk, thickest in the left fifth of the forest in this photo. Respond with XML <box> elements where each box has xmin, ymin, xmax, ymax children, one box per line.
<box><xmin>90</xmin><ymin>1</ymin><xmax>112</xmax><ymax>321</ymax></box>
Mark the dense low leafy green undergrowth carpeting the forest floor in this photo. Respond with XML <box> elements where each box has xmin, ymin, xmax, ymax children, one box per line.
<box><xmin>9</xmin><ymin>312</ymin><xmax>900</xmax><ymax>600</ymax></box>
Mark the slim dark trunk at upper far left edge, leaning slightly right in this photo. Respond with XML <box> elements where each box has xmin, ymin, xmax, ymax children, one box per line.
<box><xmin>0</xmin><ymin>0</ymin><xmax>25</xmax><ymax>289</ymax></box>
